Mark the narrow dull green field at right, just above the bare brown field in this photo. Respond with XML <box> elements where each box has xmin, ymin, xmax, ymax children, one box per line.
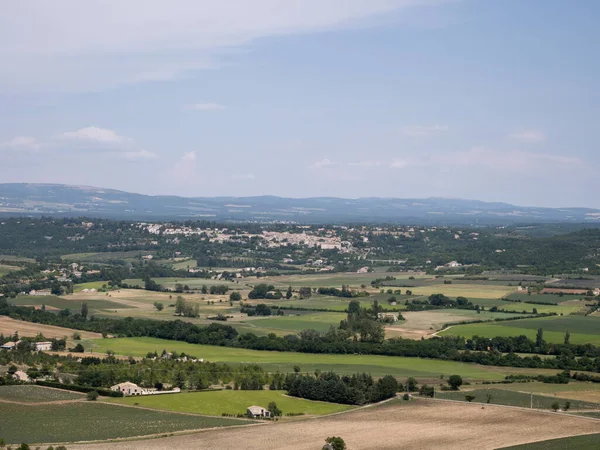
<box><xmin>435</xmin><ymin>388</ymin><xmax>600</xmax><ymax>410</ymax></box>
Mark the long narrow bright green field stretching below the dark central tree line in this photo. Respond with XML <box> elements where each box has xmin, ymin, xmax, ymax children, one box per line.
<box><xmin>93</xmin><ymin>337</ymin><xmax>556</xmax><ymax>381</ymax></box>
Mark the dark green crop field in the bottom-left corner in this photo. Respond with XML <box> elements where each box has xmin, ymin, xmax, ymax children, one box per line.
<box><xmin>1</xmin><ymin>401</ymin><xmax>249</xmax><ymax>447</ymax></box>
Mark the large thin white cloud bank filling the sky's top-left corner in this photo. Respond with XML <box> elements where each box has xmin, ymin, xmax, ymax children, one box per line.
<box><xmin>0</xmin><ymin>0</ymin><xmax>447</xmax><ymax>91</ymax></box>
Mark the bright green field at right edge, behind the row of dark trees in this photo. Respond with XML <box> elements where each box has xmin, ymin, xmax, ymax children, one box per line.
<box><xmin>440</xmin><ymin>316</ymin><xmax>600</xmax><ymax>345</ymax></box>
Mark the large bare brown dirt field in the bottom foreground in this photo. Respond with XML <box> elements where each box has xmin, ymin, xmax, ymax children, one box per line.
<box><xmin>68</xmin><ymin>400</ymin><xmax>600</xmax><ymax>450</ymax></box>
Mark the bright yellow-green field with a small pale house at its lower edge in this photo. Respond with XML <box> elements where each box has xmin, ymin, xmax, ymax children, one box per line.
<box><xmin>109</xmin><ymin>390</ymin><xmax>352</xmax><ymax>416</ymax></box>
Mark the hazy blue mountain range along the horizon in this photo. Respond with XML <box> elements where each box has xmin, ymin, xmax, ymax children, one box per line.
<box><xmin>0</xmin><ymin>183</ymin><xmax>600</xmax><ymax>225</ymax></box>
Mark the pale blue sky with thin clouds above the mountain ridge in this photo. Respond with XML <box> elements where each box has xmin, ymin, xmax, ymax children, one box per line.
<box><xmin>0</xmin><ymin>0</ymin><xmax>600</xmax><ymax>208</ymax></box>
